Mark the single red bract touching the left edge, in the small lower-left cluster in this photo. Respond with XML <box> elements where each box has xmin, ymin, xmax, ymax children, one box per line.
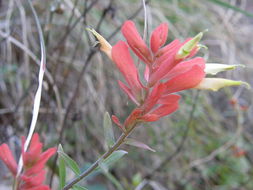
<box><xmin>0</xmin><ymin>144</ymin><xmax>17</xmax><ymax>176</ymax></box>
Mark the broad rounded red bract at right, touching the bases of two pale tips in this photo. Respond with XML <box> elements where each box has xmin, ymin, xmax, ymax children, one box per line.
<box><xmin>165</xmin><ymin>65</ymin><xmax>205</xmax><ymax>94</ymax></box>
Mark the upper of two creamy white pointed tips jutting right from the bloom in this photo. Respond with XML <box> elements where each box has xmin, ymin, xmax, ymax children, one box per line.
<box><xmin>205</xmin><ymin>63</ymin><xmax>245</xmax><ymax>75</ymax></box>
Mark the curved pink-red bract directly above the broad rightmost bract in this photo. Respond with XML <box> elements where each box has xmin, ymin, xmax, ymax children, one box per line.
<box><xmin>164</xmin><ymin>57</ymin><xmax>205</xmax><ymax>79</ymax></box>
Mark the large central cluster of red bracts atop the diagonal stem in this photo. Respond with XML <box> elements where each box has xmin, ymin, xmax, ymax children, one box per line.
<box><xmin>111</xmin><ymin>21</ymin><xmax>205</xmax><ymax>131</ymax></box>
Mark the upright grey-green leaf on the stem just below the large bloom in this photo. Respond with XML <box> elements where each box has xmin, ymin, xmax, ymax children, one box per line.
<box><xmin>103</xmin><ymin>112</ymin><xmax>115</xmax><ymax>148</ymax></box>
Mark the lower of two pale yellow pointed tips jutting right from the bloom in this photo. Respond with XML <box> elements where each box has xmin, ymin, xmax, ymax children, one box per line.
<box><xmin>195</xmin><ymin>78</ymin><xmax>250</xmax><ymax>91</ymax></box>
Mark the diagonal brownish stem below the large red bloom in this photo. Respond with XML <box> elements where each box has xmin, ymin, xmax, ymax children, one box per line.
<box><xmin>62</xmin><ymin>125</ymin><xmax>136</xmax><ymax>190</ymax></box>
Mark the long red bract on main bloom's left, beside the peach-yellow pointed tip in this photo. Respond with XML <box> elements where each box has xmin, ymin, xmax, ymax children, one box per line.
<box><xmin>112</xmin><ymin>41</ymin><xmax>143</xmax><ymax>96</ymax></box>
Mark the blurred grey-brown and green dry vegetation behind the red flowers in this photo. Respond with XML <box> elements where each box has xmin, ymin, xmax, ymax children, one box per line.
<box><xmin>0</xmin><ymin>0</ymin><xmax>253</xmax><ymax>190</ymax></box>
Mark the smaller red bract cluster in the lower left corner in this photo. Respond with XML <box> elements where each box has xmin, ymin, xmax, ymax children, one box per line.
<box><xmin>0</xmin><ymin>133</ymin><xmax>56</xmax><ymax>190</ymax></box>
